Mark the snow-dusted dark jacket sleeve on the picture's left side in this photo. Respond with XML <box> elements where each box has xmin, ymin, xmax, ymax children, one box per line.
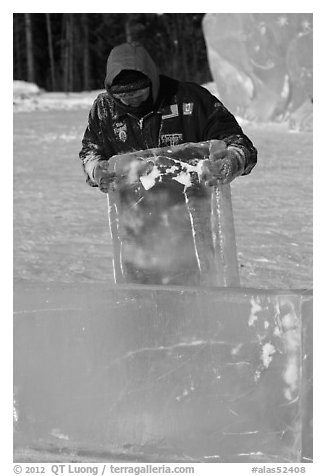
<box><xmin>79</xmin><ymin>98</ymin><xmax>114</xmax><ymax>187</ymax></box>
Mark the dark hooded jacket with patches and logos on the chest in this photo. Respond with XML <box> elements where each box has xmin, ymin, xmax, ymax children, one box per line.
<box><xmin>79</xmin><ymin>43</ymin><xmax>257</xmax><ymax>187</ymax></box>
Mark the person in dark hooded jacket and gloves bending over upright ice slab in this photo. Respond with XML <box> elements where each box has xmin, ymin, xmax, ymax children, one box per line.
<box><xmin>79</xmin><ymin>43</ymin><xmax>257</xmax><ymax>283</ymax></box>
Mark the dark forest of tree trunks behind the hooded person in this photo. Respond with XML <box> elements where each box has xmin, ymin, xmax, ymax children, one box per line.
<box><xmin>13</xmin><ymin>13</ymin><xmax>211</xmax><ymax>92</ymax></box>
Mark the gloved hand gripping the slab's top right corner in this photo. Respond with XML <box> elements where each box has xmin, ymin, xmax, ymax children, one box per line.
<box><xmin>203</xmin><ymin>146</ymin><xmax>245</xmax><ymax>186</ymax></box>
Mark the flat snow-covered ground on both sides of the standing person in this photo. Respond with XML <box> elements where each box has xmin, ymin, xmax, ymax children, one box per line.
<box><xmin>14</xmin><ymin>82</ymin><xmax>312</xmax><ymax>289</ymax></box>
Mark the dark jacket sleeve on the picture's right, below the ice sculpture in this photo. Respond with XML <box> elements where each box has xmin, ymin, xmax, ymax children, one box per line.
<box><xmin>199</xmin><ymin>88</ymin><xmax>257</xmax><ymax>175</ymax></box>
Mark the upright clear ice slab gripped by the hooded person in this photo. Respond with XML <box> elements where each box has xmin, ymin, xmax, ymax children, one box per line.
<box><xmin>109</xmin><ymin>140</ymin><xmax>239</xmax><ymax>286</ymax></box>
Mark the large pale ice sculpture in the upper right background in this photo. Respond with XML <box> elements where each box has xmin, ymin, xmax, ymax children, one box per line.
<box><xmin>203</xmin><ymin>13</ymin><xmax>313</xmax><ymax>129</ymax></box>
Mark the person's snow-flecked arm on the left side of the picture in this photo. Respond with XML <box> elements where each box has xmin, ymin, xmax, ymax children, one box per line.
<box><xmin>79</xmin><ymin>99</ymin><xmax>114</xmax><ymax>192</ymax></box>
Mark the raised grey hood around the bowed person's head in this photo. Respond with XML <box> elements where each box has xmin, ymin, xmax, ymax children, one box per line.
<box><xmin>104</xmin><ymin>43</ymin><xmax>160</xmax><ymax>102</ymax></box>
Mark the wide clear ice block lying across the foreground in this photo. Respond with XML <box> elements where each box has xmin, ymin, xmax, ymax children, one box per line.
<box><xmin>14</xmin><ymin>283</ymin><xmax>312</xmax><ymax>462</ymax></box>
